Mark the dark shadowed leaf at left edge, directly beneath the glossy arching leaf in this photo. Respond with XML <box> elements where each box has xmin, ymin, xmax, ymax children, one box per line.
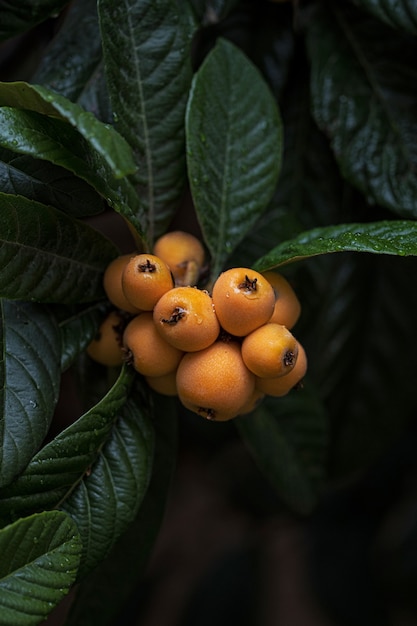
<box><xmin>0</xmin><ymin>149</ymin><xmax>105</xmax><ymax>217</ymax></box>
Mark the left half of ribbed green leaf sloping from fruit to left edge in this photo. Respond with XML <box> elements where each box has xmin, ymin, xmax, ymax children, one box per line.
<box><xmin>0</xmin><ymin>368</ymin><xmax>134</xmax><ymax>523</ymax></box>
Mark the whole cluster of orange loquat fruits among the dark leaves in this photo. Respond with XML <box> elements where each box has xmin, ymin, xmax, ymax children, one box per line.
<box><xmin>87</xmin><ymin>231</ymin><xmax>307</xmax><ymax>421</ymax></box>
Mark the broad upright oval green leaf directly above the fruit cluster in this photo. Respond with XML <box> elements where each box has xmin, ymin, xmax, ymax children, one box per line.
<box><xmin>186</xmin><ymin>39</ymin><xmax>282</xmax><ymax>277</ymax></box>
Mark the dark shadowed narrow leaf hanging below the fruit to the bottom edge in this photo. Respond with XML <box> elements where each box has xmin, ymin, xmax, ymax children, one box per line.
<box><xmin>67</xmin><ymin>397</ymin><xmax>177</xmax><ymax>626</ymax></box>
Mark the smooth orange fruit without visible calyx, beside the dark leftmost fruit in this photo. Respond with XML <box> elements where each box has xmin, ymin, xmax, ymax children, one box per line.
<box><xmin>123</xmin><ymin>311</ymin><xmax>183</xmax><ymax>376</ymax></box>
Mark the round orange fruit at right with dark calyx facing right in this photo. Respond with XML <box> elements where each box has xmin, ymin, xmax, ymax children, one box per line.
<box><xmin>242</xmin><ymin>322</ymin><xmax>298</xmax><ymax>378</ymax></box>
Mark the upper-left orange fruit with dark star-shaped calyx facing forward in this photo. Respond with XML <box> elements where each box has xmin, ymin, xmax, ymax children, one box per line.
<box><xmin>122</xmin><ymin>254</ymin><xmax>174</xmax><ymax>311</ymax></box>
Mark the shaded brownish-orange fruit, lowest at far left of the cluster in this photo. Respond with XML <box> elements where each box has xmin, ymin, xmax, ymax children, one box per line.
<box><xmin>87</xmin><ymin>311</ymin><xmax>124</xmax><ymax>367</ymax></box>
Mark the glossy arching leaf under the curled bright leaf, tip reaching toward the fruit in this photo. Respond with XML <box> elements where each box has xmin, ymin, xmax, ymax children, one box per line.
<box><xmin>0</xmin><ymin>107</ymin><xmax>142</xmax><ymax>238</ymax></box>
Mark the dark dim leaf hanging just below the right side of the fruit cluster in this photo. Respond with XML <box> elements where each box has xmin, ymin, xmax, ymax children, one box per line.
<box><xmin>236</xmin><ymin>385</ymin><xmax>328</xmax><ymax>515</ymax></box>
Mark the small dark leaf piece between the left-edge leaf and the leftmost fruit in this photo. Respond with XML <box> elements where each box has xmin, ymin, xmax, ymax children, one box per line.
<box><xmin>54</xmin><ymin>303</ymin><xmax>107</xmax><ymax>371</ymax></box>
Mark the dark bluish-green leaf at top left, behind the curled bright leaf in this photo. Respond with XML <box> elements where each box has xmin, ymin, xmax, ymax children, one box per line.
<box><xmin>31</xmin><ymin>0</ymin><xmax>102</xmax><ymax>103</ymax></box>
